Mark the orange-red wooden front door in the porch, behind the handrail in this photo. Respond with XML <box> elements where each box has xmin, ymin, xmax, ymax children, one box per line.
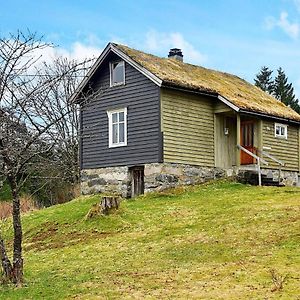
<box><xmin>241</xmin><ymin>121</ymin><xmax>255</xmax><ymax>165</ymax></box>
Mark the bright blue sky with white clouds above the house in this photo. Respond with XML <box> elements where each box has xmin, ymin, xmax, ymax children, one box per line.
<box><xmin>0</xmin><ymin>0</ymin><xmax>300</xmax><ymax>98</ymax></box>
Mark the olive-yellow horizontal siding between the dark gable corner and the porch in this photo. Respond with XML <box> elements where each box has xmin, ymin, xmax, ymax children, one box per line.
<box><xmin>161</xmin><ymin>89</ymin><xmax>214</xmax><ymax>167</ymax></box>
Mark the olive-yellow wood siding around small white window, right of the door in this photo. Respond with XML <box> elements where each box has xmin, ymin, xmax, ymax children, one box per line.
<box><xmin>262</xmin><ymin>121</ymin><xmax>299</xmax><ymax>171</ymax></box>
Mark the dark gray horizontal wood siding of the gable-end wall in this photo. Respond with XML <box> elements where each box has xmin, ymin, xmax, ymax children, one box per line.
<box><xmin>80</xmin><ymin>54</ymin><xmax>161</xmax><ymax>169</ymax></box>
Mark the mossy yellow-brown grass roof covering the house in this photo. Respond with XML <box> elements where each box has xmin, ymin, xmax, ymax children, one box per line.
<box><xmin>115</xmin><ymin>44</ymin><xmax>300</xmax><ymax>121</ymax></box>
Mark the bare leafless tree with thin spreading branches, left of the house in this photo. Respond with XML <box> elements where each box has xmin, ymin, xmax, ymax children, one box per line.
<box><xmin>0</xmin><ymin>32</ymin><xmax>91</xmax><ymax>284</ymax></box>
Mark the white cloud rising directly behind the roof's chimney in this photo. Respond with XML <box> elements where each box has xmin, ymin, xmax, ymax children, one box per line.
<box><xmin>144</xmin><ymin>30</ymin><xmax>207</xmax><ymax>64</ymax></box>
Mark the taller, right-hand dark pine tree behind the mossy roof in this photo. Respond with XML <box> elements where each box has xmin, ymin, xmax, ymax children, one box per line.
<box><xmin>273</xmin><ymin>67</ymin><xmax>300</xmax><ymax>112</ymax></box>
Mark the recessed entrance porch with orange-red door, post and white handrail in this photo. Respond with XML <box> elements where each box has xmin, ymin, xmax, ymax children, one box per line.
<box><xmin>215</xmin><ymin>111</ymin><xmax>284</xmax><ymax>185</ymax></box>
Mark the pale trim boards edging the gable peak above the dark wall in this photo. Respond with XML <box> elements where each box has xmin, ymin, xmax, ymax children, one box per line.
<box><xmin>70</xmin><ymin>43</ymin><xmax>162</xmax><ymax>103</ymax></box>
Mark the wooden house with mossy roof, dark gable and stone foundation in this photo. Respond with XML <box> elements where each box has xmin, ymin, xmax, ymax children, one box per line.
<box><xmin>71</xmin><ymin>43</ymin><xmax>300</xmax><ymax>196</ymax></box>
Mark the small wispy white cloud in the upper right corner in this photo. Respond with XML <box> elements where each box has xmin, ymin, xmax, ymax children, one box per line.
<box><xmin>265</xmin><ymin>11</ymin><xmax>300</xmax><ymax>40</ymax></box>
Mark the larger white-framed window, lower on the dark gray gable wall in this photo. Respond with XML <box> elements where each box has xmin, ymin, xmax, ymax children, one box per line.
<box><xmin>107</xmin><ymin>107</ymin><xmax>127</xmax><ymax>148</ymax></box>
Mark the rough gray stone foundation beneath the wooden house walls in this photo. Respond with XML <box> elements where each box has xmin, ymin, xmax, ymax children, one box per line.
<box><xmin>81</xmin><ymin>163</ymin><xmax>299</xmax><ymax>198</ymax></box>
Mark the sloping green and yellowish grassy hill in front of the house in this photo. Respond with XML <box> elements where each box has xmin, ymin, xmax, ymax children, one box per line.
<box><xmin>0</xmin><ymin>182</ymin><xmax>300</xmax><ymax>299</ymax></box>
